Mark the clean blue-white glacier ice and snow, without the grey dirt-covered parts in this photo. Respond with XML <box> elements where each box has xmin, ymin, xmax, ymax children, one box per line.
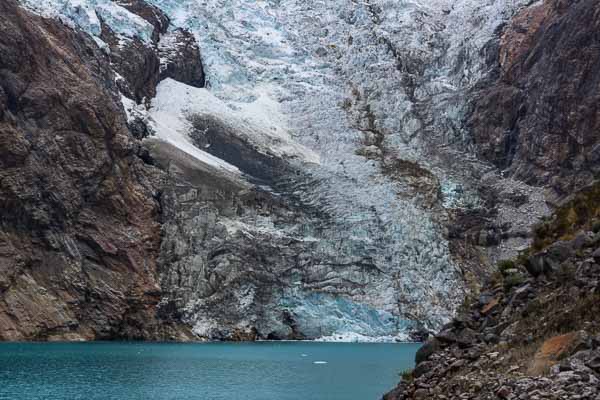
<box><xmin>23</xmin><ymin>0</ymin><xmax>526</xmax><ymax>340</ymax></box>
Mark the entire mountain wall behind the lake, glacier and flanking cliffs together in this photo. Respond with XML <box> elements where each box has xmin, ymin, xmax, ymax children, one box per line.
<box><xmin>0</xmin><ymin>0</ymin><xmax>597</xmax><ymax>346</ymax></box>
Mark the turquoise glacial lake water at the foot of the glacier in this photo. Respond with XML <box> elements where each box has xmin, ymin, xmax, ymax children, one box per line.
<box><xmin>0</xmin><ymin>342</ymin><xmax>419</xmax><ymax>400</ymax></box>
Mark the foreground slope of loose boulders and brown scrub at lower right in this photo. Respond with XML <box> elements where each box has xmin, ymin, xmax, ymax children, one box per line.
<box><xmin>384</xmin><ymin>184</ymin><xmax>600</xmax><ymax>400</ymax></box>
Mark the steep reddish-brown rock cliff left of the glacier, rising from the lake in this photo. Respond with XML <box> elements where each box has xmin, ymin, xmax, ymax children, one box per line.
<box><xmin>0</xmin><ymin>0</ymin><xmax>190</xmax><ymax>340</ymax></box>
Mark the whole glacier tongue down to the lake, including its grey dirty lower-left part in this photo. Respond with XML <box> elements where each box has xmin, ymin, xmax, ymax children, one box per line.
<box><xmin>25</xmin><ymin>0</ymin><xmax>526</xmax><ymax>337</ymax></box>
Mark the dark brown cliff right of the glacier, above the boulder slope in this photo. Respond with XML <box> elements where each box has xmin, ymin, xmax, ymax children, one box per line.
<box><xmin>470</xmin><ymin>0</ymin><xmax>600</xmax><ymax>194</ymax></box>
